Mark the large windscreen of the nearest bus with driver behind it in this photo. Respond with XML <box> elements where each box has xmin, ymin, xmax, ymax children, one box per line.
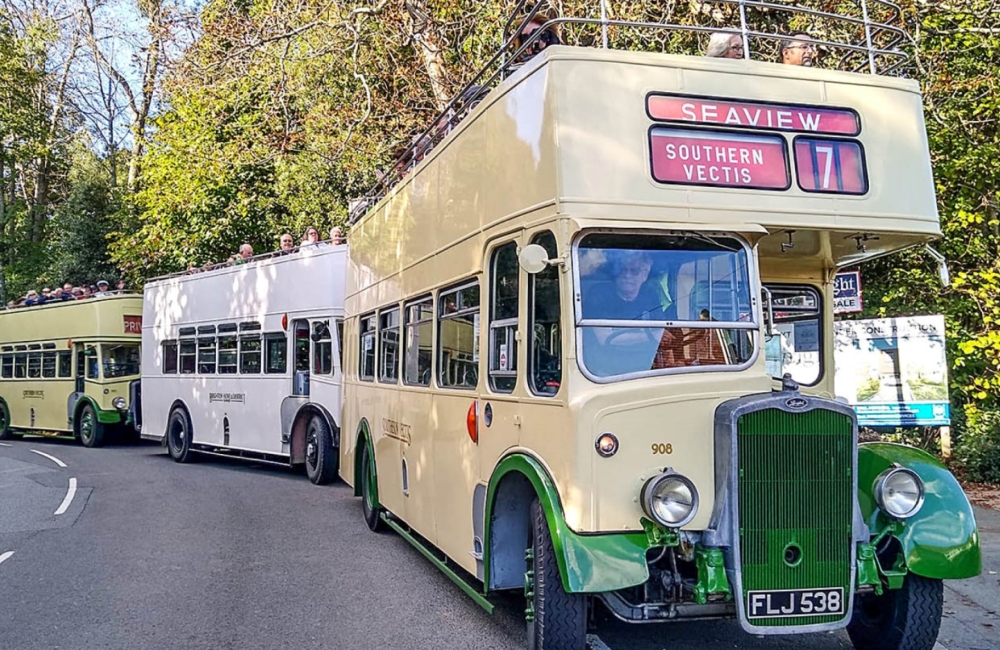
<box><xmin>576</xmin><ymin>233</ymin><xmax>756</xmax><ymax>381</ymax></box>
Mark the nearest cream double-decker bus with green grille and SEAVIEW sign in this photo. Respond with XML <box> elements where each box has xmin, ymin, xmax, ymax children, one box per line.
<box><xmin>340</xmin><ymin>2</ymin><xmax>981</xmax><ymax>650</ymax></box>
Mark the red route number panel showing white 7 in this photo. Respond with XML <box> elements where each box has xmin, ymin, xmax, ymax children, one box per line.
<box><xmin>794</xmin><ymin>137</ymin><xmax>868</xmax><ymax>194</ymax></box>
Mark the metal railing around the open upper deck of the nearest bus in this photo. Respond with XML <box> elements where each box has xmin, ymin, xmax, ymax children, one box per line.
<box><xmin>349</xmin><ymin>0</ymin><xmax>911</xmax><ymax>224</ymax></box>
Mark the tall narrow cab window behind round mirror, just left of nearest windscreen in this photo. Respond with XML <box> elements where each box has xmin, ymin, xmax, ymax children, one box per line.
<box><xmin>528</xmin><ymin>232</ymin><xmax>562</xmax><ymax>396</ymax></box>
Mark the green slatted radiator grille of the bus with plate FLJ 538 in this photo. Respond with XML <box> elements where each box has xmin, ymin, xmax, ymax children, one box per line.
<box><xmin>737</xmin><ymin>408</ymin><xmax>854</xmax><ymax>627</ymax></box>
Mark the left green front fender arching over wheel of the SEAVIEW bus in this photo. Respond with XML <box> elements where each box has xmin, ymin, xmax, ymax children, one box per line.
<box><xmin>483</xmin><ymin>454</ymin><xmax>649</xmax><ymax>593</ymax></box>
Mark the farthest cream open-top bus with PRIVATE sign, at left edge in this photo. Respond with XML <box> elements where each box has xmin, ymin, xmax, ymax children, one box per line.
<box><xmin>0</xmin><ymin>295</ymin><xmax>142</xmax><ymax>447</ymax></box>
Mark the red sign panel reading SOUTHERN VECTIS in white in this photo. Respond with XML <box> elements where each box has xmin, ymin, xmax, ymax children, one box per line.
<box><xmin>649</xmin><ymin>127</ymin><xmax>791</xmax><ymax>190</ymax></box>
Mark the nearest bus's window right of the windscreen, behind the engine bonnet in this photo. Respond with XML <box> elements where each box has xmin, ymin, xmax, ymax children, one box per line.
<box><xmin>764</xmin><ymin>285</ymin><xmax>823</xmax><ymax>386</ymax></box>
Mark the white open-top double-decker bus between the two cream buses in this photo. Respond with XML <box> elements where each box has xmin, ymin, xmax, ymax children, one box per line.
<box><xmin>141</xmin><ymin>244</ymin><xmax>347</xmax><ymax>484</ymax></box>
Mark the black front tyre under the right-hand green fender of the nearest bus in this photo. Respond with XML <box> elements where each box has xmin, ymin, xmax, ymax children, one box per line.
<box><xmin>847</xmin><ymin>573</ymin><xmax>944</xmax><ymax>650</ymax></box>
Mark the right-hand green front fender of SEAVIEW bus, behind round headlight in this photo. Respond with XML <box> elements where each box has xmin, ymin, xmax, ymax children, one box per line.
<box><xmin>858</xmin><ymin>443</ymin><xmax>982</xmax><ymax>579</ymax></box>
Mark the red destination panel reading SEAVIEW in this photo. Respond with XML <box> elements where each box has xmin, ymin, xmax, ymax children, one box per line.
<box><xmin>646</xmin><ymin>94</ymin><xmax>861</xmax><ymax>135</ymax></box>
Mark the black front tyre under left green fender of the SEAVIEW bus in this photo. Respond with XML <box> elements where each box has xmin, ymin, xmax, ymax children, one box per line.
<box><xmin>526</xmin><ymin>499</ymin><xmax>587</xmax><ymax>650</ymax></box>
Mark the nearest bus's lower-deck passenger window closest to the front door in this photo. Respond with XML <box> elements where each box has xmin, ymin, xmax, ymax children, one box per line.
<box><xmin>438</xmin><ymin>281</ymin><xmax>479</xmax><ymax>389</ymax></box>
